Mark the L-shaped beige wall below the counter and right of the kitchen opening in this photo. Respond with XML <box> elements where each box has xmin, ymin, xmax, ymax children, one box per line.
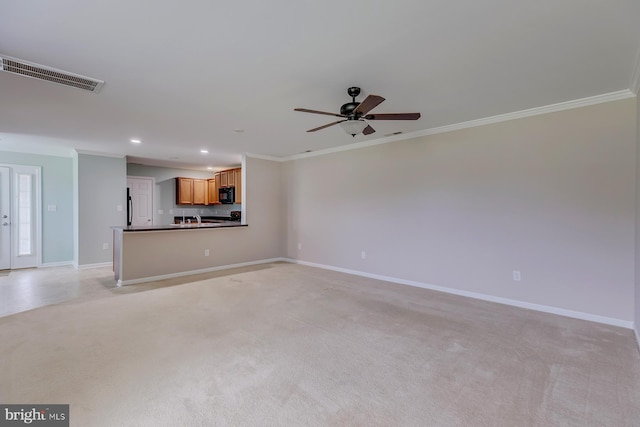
<box><xmin>121</xmin><ymin>158</ymin><xmax>286</xmax><ymax>284</ymax></box>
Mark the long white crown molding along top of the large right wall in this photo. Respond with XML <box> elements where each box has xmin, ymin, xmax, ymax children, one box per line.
<box><xmin>280</xmin><ymin>90</ymin><xmax>640</xmax><ymax>161</ymax></box>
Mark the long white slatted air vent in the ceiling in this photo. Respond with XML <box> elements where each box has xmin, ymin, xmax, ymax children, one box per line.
<box><xmin>0</xmin><ymin>55</ymin><xmax>104</xmax><ymax>92</ymax></box>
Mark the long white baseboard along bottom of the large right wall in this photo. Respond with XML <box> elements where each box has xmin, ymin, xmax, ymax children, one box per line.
<box><xmin>283</xmin><ymin>258</ymin><xmax>640</xmax><ymax>332</ymax></box>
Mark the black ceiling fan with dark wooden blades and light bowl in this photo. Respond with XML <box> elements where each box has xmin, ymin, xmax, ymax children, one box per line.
<box><xmin>294</xmin><ymin>87</ymin><xmax>420</xmax><ymax>136</ymax></box>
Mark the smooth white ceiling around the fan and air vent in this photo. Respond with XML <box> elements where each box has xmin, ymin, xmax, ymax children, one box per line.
<box><xmin>0</xmin><ymin>0</ymin><xmax>640</xmax><ymax>172</ymax></box>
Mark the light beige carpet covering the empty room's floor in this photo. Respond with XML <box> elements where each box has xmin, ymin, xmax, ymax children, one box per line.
<box><xmin>0</xmin><ymin>263</ymin><xmax>640</xmax><ymax>427</ymax></box>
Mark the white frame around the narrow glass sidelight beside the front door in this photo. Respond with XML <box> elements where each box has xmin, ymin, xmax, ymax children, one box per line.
<box><xmin>0</xmin><ymin>163</ymin><xmax>42</xmax><ymax>268</ymax></box>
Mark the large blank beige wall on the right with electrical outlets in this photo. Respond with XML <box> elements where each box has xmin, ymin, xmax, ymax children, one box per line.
<box><xmin>284</xmin><ymin>99</ymin><xmax>636</xmax><ymax>323</ymax></box>
